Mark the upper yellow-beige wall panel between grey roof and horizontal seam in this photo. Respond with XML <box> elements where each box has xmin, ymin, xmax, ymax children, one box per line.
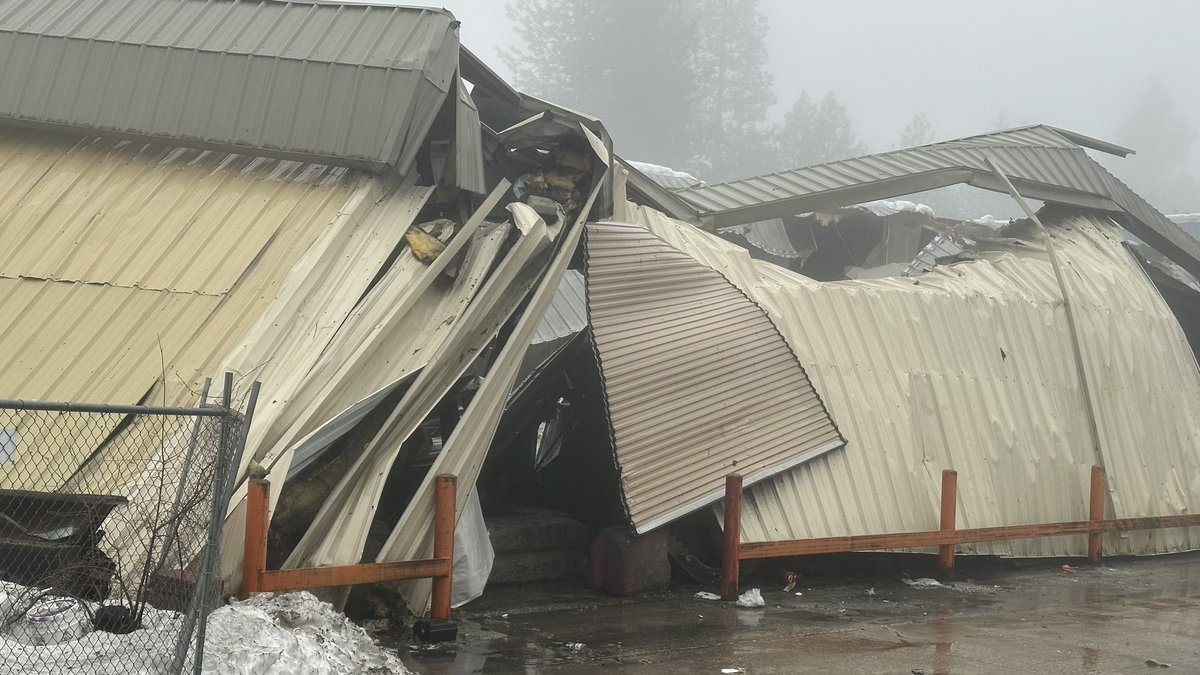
<box><xmin>0</xmin><ymin>129</ymin><xmax>355</xmax><ymax>295</ymax></box>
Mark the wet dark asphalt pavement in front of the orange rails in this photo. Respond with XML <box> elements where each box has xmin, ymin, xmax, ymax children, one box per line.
<box><xmin>400</xmin><ymin>554</ymin><xmax>1200</xmax><ymax>675</ymax></box>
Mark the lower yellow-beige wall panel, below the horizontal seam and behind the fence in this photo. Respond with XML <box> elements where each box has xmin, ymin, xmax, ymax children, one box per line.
<box><xmin>0</xmin><ymin>279</ymin><xmax>220</xmax><ymax>490</ymax></box>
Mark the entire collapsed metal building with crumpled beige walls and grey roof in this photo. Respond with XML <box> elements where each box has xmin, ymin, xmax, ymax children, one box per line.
<box><xmin>0</xmin><ymin>0</ymin><xmax>1200</xmax><ymax>613</ymax></box>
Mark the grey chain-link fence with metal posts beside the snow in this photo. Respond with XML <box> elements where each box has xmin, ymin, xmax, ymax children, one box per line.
<box><xmin>0</xmin><ymin>384</ymin><xmax>246</xmax><ymax>674</ymax></box>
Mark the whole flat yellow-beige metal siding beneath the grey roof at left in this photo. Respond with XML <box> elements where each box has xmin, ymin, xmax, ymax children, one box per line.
<box><xmin>0</xmin><ymin>129</ymin><xmax>361</xmax><ymax>482</ymax></box>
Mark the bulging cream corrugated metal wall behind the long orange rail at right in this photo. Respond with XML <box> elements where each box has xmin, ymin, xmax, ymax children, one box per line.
<box><xmin>631</xmin><ymin>207</ymin><xmax>1200</xmax><ymax>555</ymax></box>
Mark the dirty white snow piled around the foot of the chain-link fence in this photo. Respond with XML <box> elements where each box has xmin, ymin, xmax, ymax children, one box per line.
<box><xmin>0</xmin><ymin>583</ymin><xmax>408</xmax><ymax>675</ymax></box>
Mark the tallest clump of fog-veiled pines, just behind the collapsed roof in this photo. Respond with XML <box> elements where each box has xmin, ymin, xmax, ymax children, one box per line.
<box><xmin>502</xmin><ymin>0</ymin><xmax>774</xmax><ymax>181</ymax></box>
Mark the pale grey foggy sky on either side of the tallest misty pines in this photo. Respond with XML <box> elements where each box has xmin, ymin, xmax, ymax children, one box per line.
<box><xmin>444</xmin><ymin>0</ymin><xmax>1200</xmax><ymax>181</ymax></box>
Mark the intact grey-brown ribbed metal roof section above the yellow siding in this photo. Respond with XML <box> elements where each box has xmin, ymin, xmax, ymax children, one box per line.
<box><xmin>0</xmin><ymin>0</ymin><xmax>458</xmax><ymax>172</ymax></box>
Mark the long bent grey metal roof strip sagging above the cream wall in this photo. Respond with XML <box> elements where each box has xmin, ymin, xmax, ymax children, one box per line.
<box><xmin>672</xmin><ymin>125</ymin><xmax>1200</xmax><ymax>275</ymax></box>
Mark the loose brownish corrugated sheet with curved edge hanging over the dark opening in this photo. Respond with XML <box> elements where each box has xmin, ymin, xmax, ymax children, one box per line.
<box><xmin>587</xmin><ymin>223</ymin><xmax>844</xmax><ymax>532</ymax></box>
